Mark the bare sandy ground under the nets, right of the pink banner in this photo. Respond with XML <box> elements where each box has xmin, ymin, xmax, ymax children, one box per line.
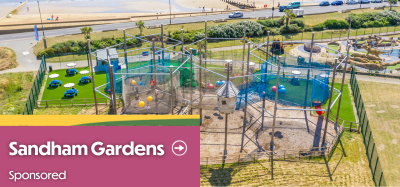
<box><xmin>198</xmin><ymin>101</ymin><xmax>337</xmax><ymax>157</ymax></box>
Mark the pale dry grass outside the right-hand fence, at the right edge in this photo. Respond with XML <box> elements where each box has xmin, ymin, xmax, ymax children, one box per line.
<box><xmin>358</xmin><ymin>81</ymin><xmax>400</xmax><ymax>186</ymax></box>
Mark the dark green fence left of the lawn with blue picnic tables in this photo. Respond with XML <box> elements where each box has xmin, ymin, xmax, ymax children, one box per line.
<box><xmin>22</xmin><ymin>56</ymin><xmax>47</xmax><ymax>115</ymax></box>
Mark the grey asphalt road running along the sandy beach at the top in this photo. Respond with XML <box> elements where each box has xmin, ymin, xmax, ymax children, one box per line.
<box><xmin>0</xmin><ymin>2</ymin><xmax>389</xmax><ymax>42</ymax></box>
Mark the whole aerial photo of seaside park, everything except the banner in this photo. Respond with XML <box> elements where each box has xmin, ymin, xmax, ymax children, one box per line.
<box><xmin>0</xmin><ymin>0</ymin><xmax>400</xmax><ymax>186</ymax></box>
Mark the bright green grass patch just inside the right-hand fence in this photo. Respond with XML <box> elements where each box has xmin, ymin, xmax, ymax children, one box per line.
<box><xmin>322</xmin><ymin>83</ymin><xmax>356</xmax><ymax>122</ymax></box>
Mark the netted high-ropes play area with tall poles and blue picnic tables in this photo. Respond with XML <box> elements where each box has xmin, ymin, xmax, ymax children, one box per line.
<box><xmin>39</xmin><ymin>26</ymin><xmax>347</xmax><ymax>178</ymax></box>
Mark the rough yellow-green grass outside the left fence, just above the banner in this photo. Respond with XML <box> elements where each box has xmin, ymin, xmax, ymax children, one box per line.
<box><xmin>0</xmin><ymin>72</ymin><xmax>35</xmax><ymax>115</ymax></box>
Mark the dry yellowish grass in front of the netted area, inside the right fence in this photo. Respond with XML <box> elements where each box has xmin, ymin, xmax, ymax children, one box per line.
<box><xmin>200</xmin><ymin>131</ymin><xmax>374</xmax><ymax>186</ymax></box>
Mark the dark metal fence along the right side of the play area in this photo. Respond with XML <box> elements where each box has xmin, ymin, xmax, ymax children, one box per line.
<box><xmin>350</xmin><ymin>68</ymin><xmax>386</xmax><ymax>186</ymax></box>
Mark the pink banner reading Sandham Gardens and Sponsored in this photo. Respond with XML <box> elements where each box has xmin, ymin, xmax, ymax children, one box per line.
<box><xmin>0</xmin><ymin>126</ymin><xmax>200</xmax><ymax>187</ymax></box>
